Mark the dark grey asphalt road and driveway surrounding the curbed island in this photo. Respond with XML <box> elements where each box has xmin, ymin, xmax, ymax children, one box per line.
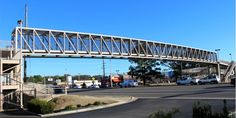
<box><xmin>0</xmin><ymin>84</ymin><xmax>235</xmax><ymax>118</ymax></box>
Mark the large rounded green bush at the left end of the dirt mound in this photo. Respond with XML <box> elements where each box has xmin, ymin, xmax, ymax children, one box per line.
<box><xmin>27</xmin><ymin>99</ymin><xmax>55</xmax><ymax>114</ymax></box>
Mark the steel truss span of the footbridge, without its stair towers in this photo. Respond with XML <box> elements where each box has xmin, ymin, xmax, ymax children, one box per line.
<box><xmin>12</xmin><ymin>27</ymin><xmax>217</xmax><ymax>64</ymax></box>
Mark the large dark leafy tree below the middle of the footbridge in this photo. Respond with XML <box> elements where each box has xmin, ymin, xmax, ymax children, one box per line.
<box><xmin>128</xmin><ymin>59</ymin><xmax>162</xmax><ymax>85</ymax></box>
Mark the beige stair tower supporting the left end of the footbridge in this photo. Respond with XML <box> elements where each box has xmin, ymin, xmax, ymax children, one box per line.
<box><xmin>0</xmin><ymin>47</ymin><xmax>23</xmax><ymax>111</ymax></box>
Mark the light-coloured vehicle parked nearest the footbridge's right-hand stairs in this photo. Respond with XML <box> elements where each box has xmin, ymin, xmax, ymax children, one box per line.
<box><xmin>198</xmin><ymin>75</ymin><xmax>220</xmax><ymax>84</ymax></box>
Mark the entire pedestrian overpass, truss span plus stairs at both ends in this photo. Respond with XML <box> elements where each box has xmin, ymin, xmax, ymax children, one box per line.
<box><xmin>0</xmin><ymin>27</ymin><xmax>236</xmax><ymax>111</ymax></box>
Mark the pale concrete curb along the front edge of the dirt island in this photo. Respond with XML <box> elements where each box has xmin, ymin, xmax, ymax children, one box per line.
<box><xmin>37</xmin><ymin>97</ymin><xmax>138</xmax><ymax>117</ymax></box>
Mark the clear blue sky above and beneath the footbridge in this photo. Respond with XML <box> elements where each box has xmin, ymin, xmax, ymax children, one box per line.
<box><xmin>0</xmin><ymin>0</ymin><xmax>236</xmax><ymax>75</ymax></box>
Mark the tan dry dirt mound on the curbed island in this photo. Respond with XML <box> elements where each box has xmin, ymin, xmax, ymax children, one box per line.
<box><xmin>49</xmin><ymin>95</ymin><xmax>117</xmax><ymax>110</ymax></box>
